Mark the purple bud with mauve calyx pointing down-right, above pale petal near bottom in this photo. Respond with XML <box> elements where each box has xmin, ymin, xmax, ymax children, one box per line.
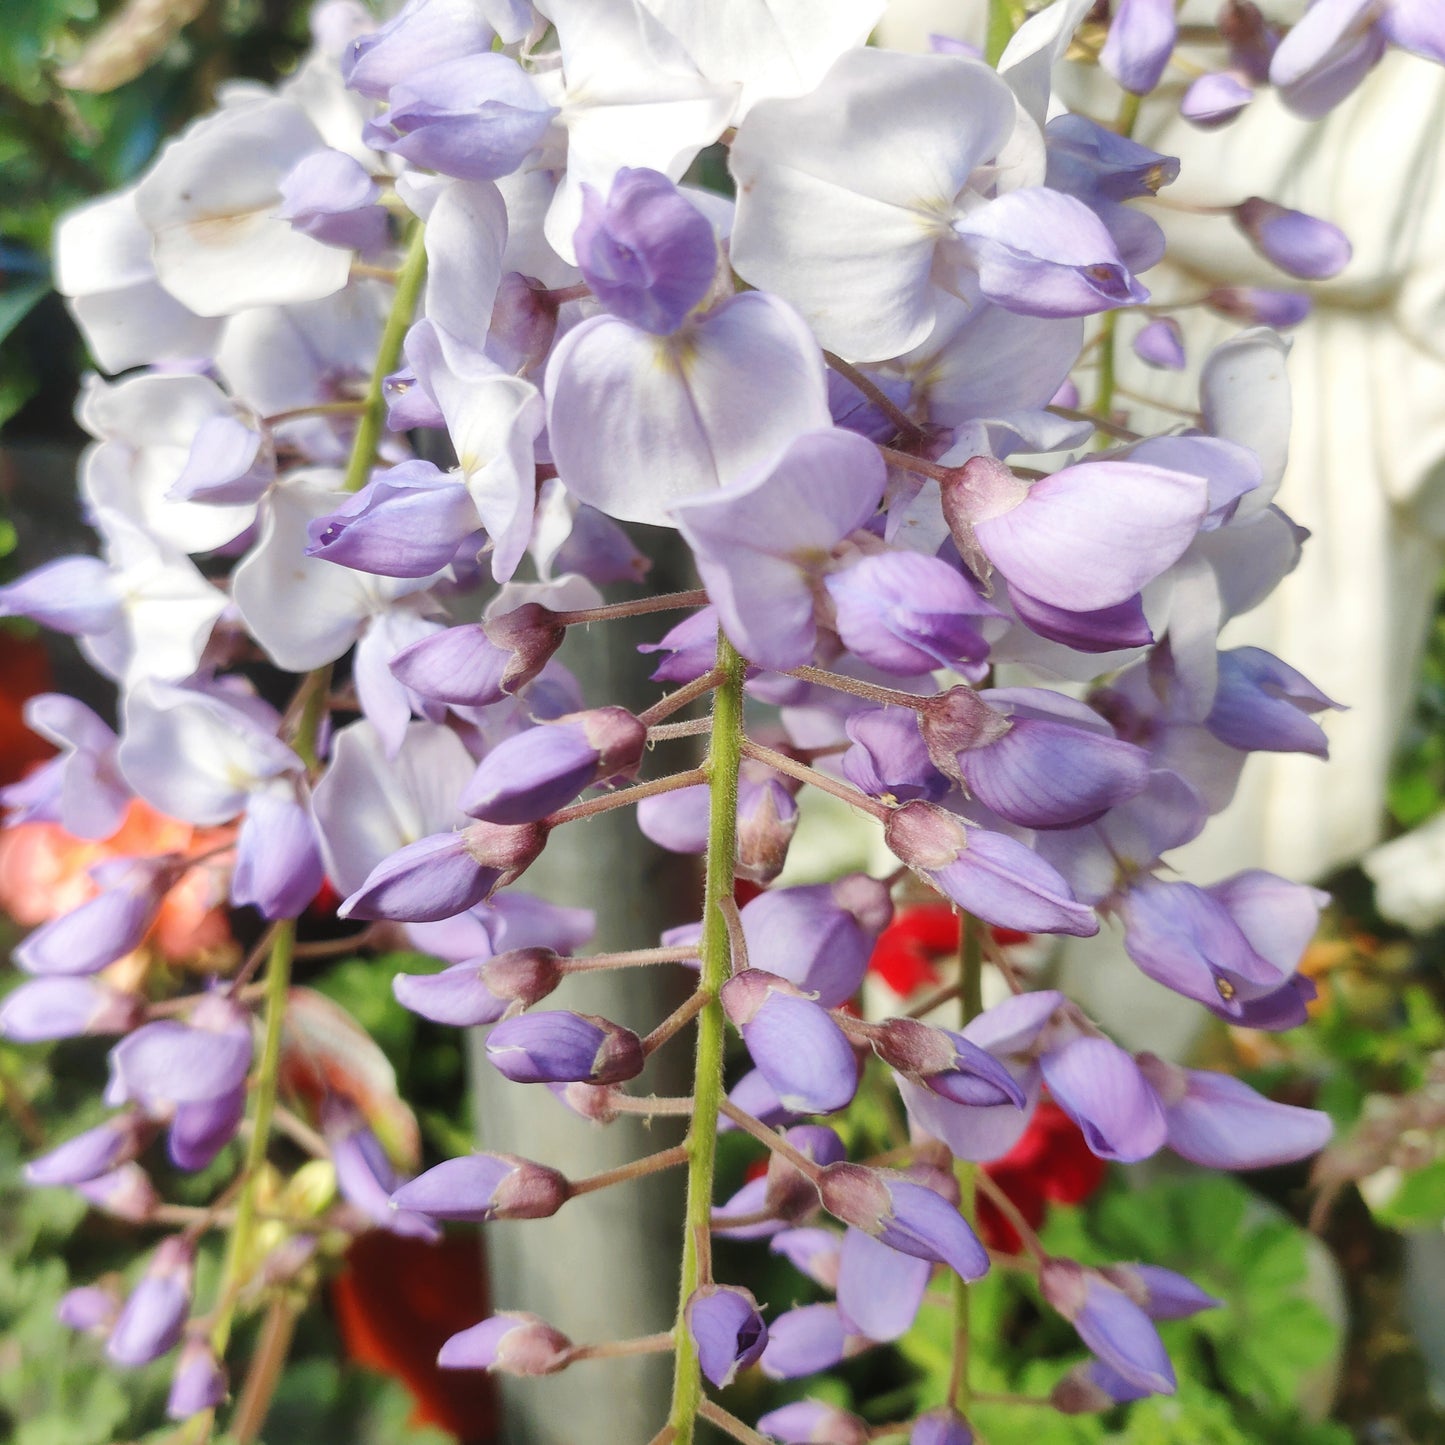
<box><xmin>818</xmin><ymin>1163</ymin><xmax>988</xmax><ymax>1280</ymax></box>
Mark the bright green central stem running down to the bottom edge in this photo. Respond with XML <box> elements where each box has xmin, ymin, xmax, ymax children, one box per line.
<box><xmin>668</xmin><ymin>633</ymin><xmax>744</xmax><ymax>1445</ymax></box>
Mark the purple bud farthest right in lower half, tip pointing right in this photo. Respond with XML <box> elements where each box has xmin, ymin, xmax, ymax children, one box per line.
<box><xmin>1139</xmin><ymin>1055</ymin><xmax>1334</xmax><ymax>1169</ymax></box>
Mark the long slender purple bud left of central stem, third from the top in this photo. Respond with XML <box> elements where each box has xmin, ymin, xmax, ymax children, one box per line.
<box><xmin>337</xmin><ymin>822</ymin><xmax>548</xmax><ymax>923</ymax></box>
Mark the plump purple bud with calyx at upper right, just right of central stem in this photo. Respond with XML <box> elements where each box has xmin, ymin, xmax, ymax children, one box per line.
<box><xmin>741</xmin><ymin>873</ymin><xmax>893</xmax><ymax>1009</ymax></box>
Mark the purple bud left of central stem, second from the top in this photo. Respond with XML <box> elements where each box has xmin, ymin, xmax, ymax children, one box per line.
<box><xmin>461</xmin><ymin>707</ymin><xmax>647</xmax><ymax>825</ymax></box>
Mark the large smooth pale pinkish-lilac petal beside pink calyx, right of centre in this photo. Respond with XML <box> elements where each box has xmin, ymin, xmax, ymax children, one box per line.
<box><xmin>972</xmin><ymin>461</ymin><xmax>1208</xmax><ymax>613</ymax></box>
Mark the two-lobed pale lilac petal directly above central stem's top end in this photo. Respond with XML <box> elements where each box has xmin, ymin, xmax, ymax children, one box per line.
<box><xmin>672</xmin><ymin>428</ymin><xmax>890</xmax><ymax>672</ymax></box>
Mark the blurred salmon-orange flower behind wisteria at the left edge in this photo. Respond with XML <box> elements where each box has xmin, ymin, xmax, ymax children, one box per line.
<box><xmin>0</xmin><ymin>798</ymin><xmax>240</xmax><ymax>981</ymax></box>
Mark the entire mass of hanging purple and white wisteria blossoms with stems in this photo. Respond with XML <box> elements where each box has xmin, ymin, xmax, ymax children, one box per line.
<box><xmin>0</xmin><ymin>0</ymin><xmax>1445</xmax><ymax>1445</ymax></box>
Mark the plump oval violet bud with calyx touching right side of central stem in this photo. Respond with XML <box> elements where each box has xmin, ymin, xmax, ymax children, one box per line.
<box><xmin>721</xmin><ymin>968</ymin><xmax>858</xmax><ymax>1114</ymax></box>
